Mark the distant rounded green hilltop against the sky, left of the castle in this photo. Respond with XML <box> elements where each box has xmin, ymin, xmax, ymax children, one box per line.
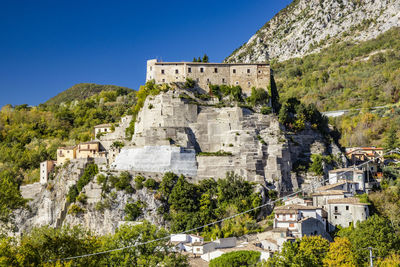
<box><xmin>45</xmin><ymin>83</ymin><xmax>133</xmax><ymax>105</ymax></box>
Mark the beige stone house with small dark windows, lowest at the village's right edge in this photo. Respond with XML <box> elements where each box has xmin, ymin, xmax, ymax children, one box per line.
<box><xmin>327</xmin><ymin>197</ymin><xmax>369</xmax><ymax>231</ymax></box>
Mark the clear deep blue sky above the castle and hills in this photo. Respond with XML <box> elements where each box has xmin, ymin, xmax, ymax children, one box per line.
<box><xmin>0</xmin><ymin>0</ymin><xmax>291</xmax><ymax>107</ymax></box>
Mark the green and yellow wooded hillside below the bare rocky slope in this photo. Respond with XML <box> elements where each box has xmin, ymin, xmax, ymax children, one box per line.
<box><xmin>271</xmin><ymin>28</ymin><xmax>400</xmax><ymax>146</ymax></box>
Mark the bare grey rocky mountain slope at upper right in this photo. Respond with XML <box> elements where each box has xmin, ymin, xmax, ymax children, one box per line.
<box><xmin>225</xmin><ymin>0</ymin><xmax>400</xmax><ymax>62</ymax></box>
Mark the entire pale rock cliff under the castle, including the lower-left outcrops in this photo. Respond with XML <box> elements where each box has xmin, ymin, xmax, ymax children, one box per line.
<box><xmin>16</xmin><ymin>89</ymin><xmax>340</xmax><ymax>234</ymax></box>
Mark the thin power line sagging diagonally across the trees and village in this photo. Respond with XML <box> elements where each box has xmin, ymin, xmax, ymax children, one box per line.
<box><xmin>49</xmin><ymin>149</ymin><xmax>399</xmax><ymax>262</ymax></box>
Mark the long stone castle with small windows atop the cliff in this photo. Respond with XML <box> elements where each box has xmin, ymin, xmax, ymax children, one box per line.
<box><xmin>146</xmin><ymin>59</ymin><xmax>271</xmax><ymax>95</ymax></box>
